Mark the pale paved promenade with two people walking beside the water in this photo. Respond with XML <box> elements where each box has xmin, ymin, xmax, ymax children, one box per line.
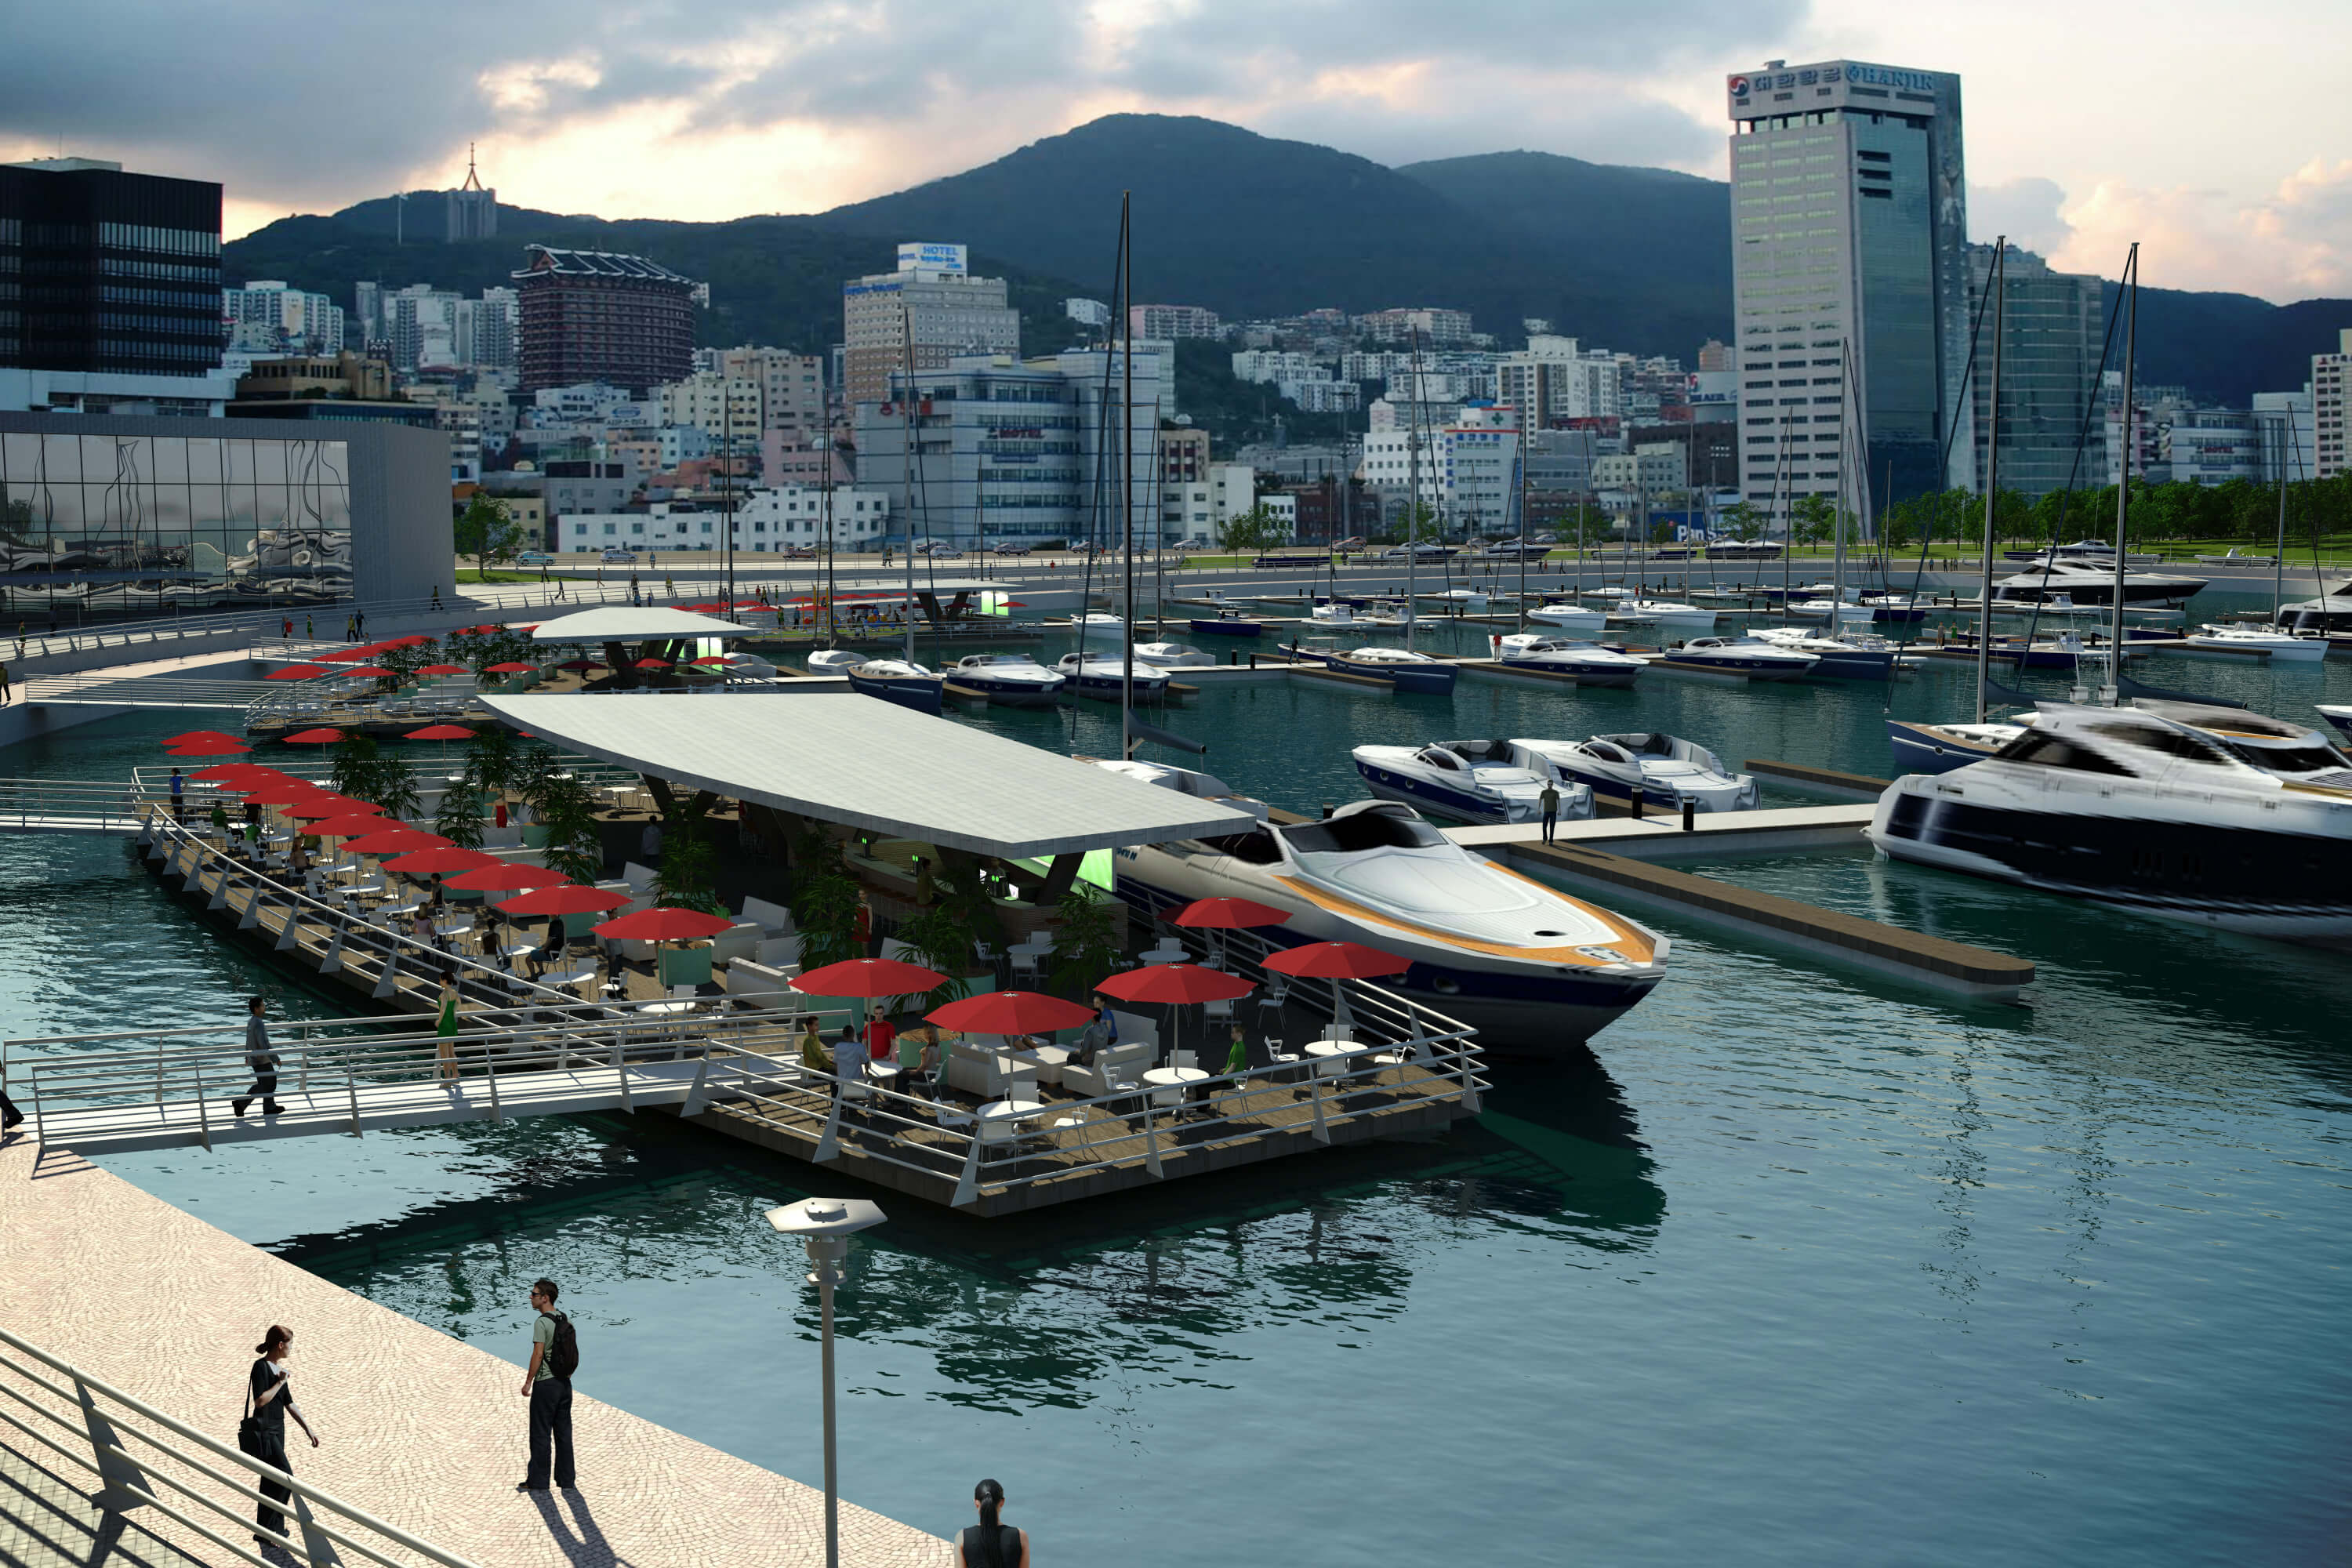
<box><xmin>0</xmin><ymin>1138</ymin><xmax>955</xmax><ymax>1568</ymax></box>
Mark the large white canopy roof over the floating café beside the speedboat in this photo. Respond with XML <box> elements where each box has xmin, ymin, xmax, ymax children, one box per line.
<box><xmin>482</xmin><ymin>691</ymin><xmax>1256</xmax><ymax>855</ymax></box>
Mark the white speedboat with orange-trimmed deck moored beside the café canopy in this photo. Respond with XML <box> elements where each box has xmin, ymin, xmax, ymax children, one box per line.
<box><xmin>1103</xmin><ymin>785</ymin><xmax>1672</xmax><ymax>1053</ymax></box>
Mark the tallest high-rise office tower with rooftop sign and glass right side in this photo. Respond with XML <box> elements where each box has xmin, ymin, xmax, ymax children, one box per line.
<box><xmin>1724</xmin><ymin>61</ymin><xmax>1976</xmax><ymax>517</ymax></box>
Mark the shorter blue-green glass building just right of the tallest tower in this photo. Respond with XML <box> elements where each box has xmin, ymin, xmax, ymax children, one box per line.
<box><xmin>1969</xmin><ymin>245</ymin><xmax>2107</xmax><ymax>501</ymax></box>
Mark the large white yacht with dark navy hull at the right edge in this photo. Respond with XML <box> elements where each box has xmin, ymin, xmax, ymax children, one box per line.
<box><xmin>1867</xmin><ymin>703</ymin><xmax>2352</xmax><ymax>945</ymax></box>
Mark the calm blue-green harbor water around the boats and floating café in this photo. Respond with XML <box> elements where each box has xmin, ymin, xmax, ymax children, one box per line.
<box><xmin>0</xmin><ymin>602</ymin><xmax>2352</xmax><ymax>1563</ymax></box>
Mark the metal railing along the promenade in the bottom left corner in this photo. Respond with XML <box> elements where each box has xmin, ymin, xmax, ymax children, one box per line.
<box><xmin>0</xmin><ymin>1328</ymin><xmax>477</xmax><ymax>1568</ymax></box>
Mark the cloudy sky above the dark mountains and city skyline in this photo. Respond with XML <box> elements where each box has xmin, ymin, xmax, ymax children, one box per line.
<box><xmin>0</xmin><ymin>0</ymin><xmax>2352</xmax><ymax>301</ymax></box>
